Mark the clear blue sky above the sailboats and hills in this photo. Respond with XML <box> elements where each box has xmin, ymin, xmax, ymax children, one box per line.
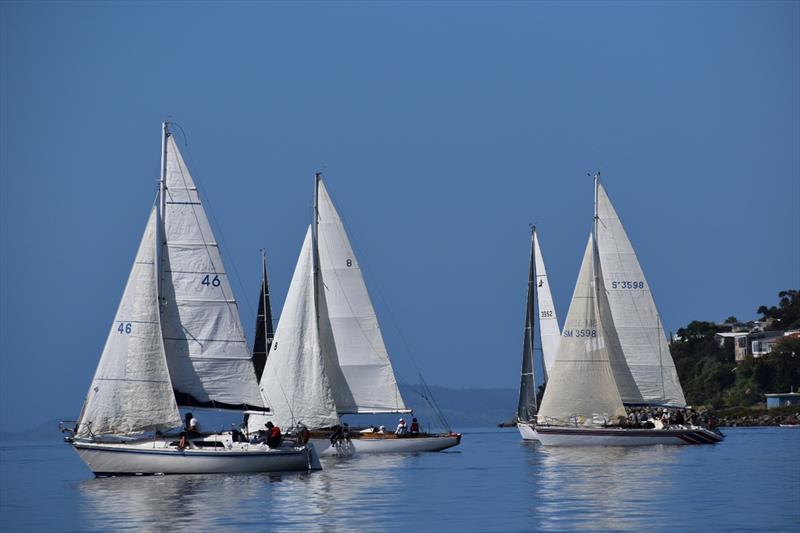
<box><xmin>0</xmin><ymin>2</ymin><xmax>800</xmax><ymax>427</ymax></box>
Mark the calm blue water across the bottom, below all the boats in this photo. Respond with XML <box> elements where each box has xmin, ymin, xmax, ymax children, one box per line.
<box><xmin>0</xmin><ymin>428</ymin><xmax>800</xmax><ymax>532</ymax></box>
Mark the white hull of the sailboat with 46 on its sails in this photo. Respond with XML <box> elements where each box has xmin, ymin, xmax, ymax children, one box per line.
<box><xmin>72</xmin><ymin>439</ymin><xmax>321</xmax><ymax>476</ymax></box>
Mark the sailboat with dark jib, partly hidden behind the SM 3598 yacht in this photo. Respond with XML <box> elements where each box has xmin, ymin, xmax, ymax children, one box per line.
<box><xmin>517</xmin><ymin>226</ymin><xmax>561</xmax><ymax>440</ymax></box>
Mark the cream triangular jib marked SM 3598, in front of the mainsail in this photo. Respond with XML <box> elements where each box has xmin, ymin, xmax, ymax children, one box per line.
<box><xmin>537</xmin><ymin>236</ymin><xmax>625</xmax><ymax>425</ymax></box>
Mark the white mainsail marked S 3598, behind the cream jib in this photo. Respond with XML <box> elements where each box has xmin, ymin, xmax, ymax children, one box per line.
<box><xmin>597</xmin><ymin>184</ymin><xmax>686</xmax><ymax>406</ymax></box>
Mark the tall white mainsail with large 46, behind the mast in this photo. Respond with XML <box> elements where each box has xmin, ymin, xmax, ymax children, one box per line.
<box><xmin>161</xmin><ymin>136</ymin><xmax>263</xmax><ymax>407</ymax></box>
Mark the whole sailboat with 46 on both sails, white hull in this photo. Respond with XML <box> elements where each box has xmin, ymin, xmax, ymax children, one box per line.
<box><xmin>65</xmin><ymin>122</ymin><xmax>319</xmax><ymax>476</ymax></box>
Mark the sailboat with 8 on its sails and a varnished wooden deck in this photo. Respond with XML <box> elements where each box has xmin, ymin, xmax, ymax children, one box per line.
<box><xmin>248</xmin><ymin>173</ymin><xmax>461</xmax><ymax>453</ymax></box>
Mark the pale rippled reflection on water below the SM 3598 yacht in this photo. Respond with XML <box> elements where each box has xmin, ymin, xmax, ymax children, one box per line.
<box><xmin>525</xmin><ymin>443</ymin><xmax>684</xmax><ymax>531</ymax></box>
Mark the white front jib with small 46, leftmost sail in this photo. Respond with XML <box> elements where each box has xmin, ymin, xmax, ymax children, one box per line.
<box><xmin>77</xmin><ymin>209</ymin><xmax>181</xmax><ymax>438</ymax></box>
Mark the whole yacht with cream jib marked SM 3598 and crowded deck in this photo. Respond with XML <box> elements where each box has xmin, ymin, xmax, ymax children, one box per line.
<box><xmin>536</xmin><ymin>174</ymin><xmax>724</xmax><ymax>446</ymax></box>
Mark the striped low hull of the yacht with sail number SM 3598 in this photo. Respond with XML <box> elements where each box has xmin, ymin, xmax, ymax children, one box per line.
<box><xmin>536</xmin><ymin>426</ymin><xmax>725</xmax><ymax>446</ymax></box>
